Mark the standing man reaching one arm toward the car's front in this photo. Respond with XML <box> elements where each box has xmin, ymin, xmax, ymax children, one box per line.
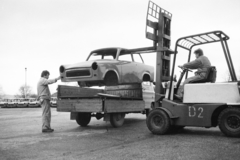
<box><xmin>37</xmin><ymin>70</ymin><xmax>61</xmax><ymax>132</ymax></box>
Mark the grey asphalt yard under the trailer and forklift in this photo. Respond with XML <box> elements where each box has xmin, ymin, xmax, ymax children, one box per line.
<box><xmin>0</xmin><ymin>108</ymin><xmax>240</xmax><ymax>160</ymax></box>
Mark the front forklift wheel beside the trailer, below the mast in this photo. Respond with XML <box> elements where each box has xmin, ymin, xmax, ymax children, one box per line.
<box><xmin>147</xmin><ymin>109</ymin><xmax>171</xmax><ymax>135</ymax></box>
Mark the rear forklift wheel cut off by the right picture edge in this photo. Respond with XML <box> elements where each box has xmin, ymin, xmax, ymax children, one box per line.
<box><xmin>218</xmin><ymin>107</ymin><xmax>240</xmax><ymax>137</ymax></box>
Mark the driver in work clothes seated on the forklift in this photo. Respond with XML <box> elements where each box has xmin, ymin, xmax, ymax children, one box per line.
<box><xmin>178</xmin><ymin>48</ymin><xmax>211</xmax><ymax>99</ymax></box>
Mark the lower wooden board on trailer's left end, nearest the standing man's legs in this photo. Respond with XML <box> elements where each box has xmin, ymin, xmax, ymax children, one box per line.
<box><xmin>57</xmin><ymin>98</ymin><xmax>103</xmax><ymax>112</ymax></box>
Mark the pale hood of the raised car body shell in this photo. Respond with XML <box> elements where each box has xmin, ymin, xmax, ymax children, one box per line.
<box><xmin>62</xmin><ymin>59</ymin><xmax>118</xmax><ymax>69</ymax></box>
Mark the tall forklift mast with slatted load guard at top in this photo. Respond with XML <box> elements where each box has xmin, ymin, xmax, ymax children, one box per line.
<box><xmin>146</xmin><ymin>1</ymin><xmax>174</xmax><ymax>107</ymax></box>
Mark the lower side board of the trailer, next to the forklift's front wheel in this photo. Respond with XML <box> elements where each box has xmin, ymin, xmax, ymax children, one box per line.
<box><xmin>104</xmin><ymin>99</ymin><xmax>145</xmax><ymax>113</ymax></box>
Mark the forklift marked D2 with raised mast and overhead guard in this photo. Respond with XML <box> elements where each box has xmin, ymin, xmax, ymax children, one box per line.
<box><xmin>146</xmin><ymin>1</ymin><xmax>240</xmax><ymax>137</ymax></box>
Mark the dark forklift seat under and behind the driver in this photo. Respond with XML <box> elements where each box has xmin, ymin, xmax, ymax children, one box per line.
<box><xmin>189</xmin><ymin>66</ymin><xmax>217</xmax><ymax>83</ymax></box>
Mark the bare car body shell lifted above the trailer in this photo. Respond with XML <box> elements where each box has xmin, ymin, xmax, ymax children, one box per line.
<box><xmin>59</xmin><ymin>48</ymin><xmax>154</xmax><ymax>87</ymax></box>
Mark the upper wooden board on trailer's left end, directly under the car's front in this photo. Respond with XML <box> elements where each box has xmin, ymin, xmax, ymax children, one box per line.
<box><xmin>58</xmin><ymin>85</ymin><xmax>104</xmax><ymax>98</ymax></box>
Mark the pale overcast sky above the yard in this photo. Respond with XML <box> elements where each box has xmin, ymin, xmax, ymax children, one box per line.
<box><xmin>0</xmin><ymin>0</ymin><xmax>240</xmax><ymax>95</ymax></box>
